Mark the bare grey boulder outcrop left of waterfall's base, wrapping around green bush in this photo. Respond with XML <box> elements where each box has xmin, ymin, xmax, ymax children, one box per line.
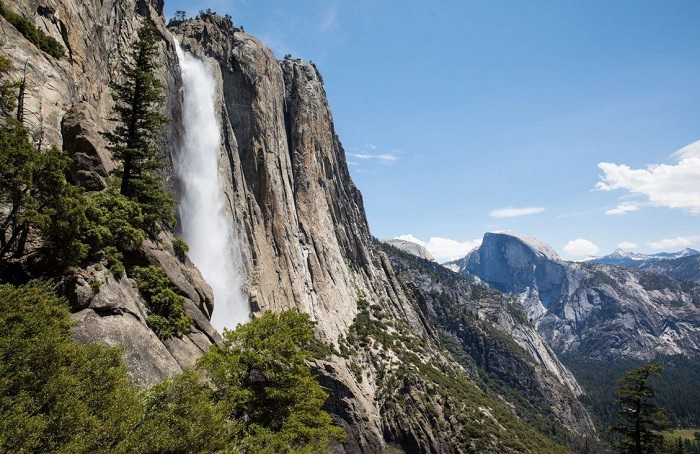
<box><xmin>61</xmin><ymin>234</ymin><xmax>221</xmax><ymax>387</ymax></box>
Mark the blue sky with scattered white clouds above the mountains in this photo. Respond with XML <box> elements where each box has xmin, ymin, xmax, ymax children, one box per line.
<box><xmin>165</xmin><ymin>0</ymin><xmax>700</xmax><ymax>260</ymax></box>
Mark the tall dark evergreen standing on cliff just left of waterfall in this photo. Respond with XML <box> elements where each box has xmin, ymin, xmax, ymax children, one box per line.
<box><xmin>105</xmin><ymin>21</ymin><xmax>175</xmax><ymax>235</ymax></box>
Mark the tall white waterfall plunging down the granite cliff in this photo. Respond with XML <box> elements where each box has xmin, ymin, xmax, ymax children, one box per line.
<box><xmin>173</xmin><ymin>43</ymin><xmax>250</xmax><ymax>332</ymax></box>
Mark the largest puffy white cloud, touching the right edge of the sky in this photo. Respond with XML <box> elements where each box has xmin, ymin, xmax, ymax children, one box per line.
<box><xmin>596</xmin><ymin>142</ymin><xmax>700</xmax><ymax>214</ymax></box>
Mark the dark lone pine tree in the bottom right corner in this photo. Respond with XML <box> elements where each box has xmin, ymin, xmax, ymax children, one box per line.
<box><xmin>610</xmin><ymin>364</ymin><xmax>668</xmax><ymax>454</ymax></box>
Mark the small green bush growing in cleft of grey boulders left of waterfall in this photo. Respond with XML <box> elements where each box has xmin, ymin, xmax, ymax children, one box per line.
<box><xmin>133</xmin><ymin>265</ymin><xmax>194</xmax><ymax>339</ymax></box>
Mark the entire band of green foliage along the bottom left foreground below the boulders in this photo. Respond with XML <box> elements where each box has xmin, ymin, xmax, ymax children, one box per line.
<box><xmin>0</xmin><ymin>279</ymin><xmax>343</xmax><ymax>454</ymax></box>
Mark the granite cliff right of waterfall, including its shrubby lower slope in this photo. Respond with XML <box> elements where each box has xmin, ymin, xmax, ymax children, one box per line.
<box><xmin>171</xmin><ymin>14</ymin><xmax>584</xmax><ymax>453</ymax></box>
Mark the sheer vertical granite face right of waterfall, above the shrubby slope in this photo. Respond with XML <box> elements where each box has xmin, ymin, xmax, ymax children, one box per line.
<box><xmin>172</xmin><ymin>15</ymin><xmax>402</xmax><ymax>342</ymax></box>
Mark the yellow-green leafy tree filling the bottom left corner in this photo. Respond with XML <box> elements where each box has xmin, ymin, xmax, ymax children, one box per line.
<box><xmin>0</xmin><ymin>284</ymin><xmax>141</xmax><ymax>453</ymax></box>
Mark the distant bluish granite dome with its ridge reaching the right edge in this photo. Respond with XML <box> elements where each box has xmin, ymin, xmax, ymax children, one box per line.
<box><xmin>459</xmin><ymin>233</ymin><xmax>700</xmax><ymax>360</ymax></box>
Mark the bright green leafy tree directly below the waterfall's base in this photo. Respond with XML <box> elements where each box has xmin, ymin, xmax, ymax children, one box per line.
<box><xmin>198</xmin><ymin>310</ymin><xmax>344</xmax><ymax>453</ymax></box>
